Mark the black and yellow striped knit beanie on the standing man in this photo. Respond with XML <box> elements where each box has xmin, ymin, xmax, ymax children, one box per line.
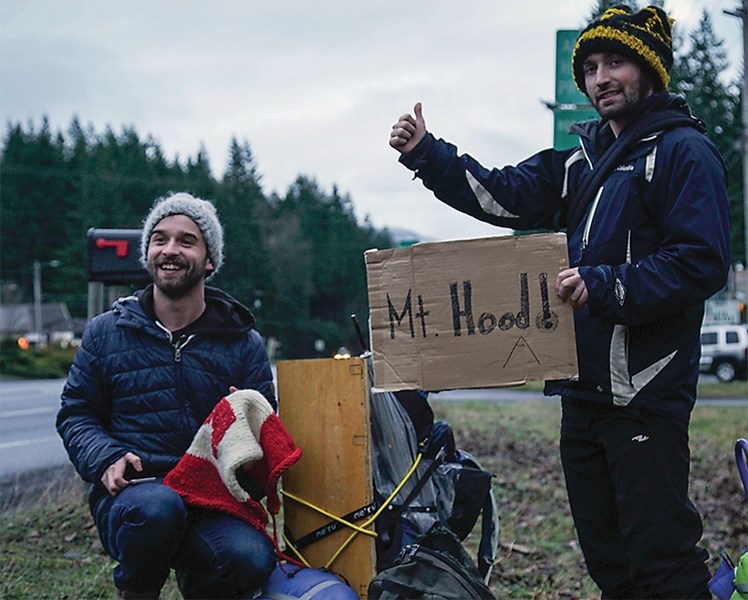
<box><xmin>571</xmin><ymin>6</ymin><xmax>673</xmax><ymax>94</ymax></box>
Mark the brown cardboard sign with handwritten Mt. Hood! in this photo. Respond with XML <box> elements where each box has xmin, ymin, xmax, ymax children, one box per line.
<box><xmin>365</xmin><ymin>233</ymin><xmax>577</xmax><ymax>391</ymax></box>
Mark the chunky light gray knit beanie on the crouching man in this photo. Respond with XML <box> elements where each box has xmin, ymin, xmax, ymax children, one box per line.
<box><xmin>140</xmin><ymin>192</ymin><xmax>223</xmax><ymax>273</ymax></box>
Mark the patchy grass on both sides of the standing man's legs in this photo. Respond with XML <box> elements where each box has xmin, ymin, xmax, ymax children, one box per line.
<box><xmin>435</xmin><ymin>403</ymin><xmax>748</xmax><ymax>598</ymax></box>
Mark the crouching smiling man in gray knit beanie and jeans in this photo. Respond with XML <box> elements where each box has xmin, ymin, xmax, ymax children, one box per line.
<box><xmin>57</xmin><ymin>193</ymin><xmax>276</xmax><ymax>598</ymax></box>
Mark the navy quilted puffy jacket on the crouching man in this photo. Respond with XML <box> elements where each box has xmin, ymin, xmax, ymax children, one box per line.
<box><xmin>57</xmin><ymin>287</ymin><xmax>275</xmax><ymax>503</ymax></box>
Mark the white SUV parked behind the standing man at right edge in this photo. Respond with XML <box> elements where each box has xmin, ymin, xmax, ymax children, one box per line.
<box><xmin>699</xmin><ymin>324</ymin><xmax>748</xmax><ymax>382</ymax></box>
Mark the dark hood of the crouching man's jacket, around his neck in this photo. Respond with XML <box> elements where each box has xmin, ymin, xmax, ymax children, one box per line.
<box><xmin>112</xmin><ymin>284</ymin><xmax>255</xmax><ymax>337</ymax></box>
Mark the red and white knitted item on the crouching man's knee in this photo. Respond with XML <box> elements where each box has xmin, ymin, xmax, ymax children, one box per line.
<box><xmin>164</xmin><ymin>390</ymin><xmax>301</xmax><ymax>531</ymax></box>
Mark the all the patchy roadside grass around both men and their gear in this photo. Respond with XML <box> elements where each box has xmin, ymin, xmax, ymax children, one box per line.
<box><xmin>0</xmin><ymin>402</ymin><xmax>748</xmax><ymax>600</ymax></box>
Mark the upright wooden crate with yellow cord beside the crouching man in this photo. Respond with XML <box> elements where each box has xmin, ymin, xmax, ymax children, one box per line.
<box><xmin>278</xmin><ymin>358</ymin><xmax>376</xmax><ymax>598</ymax></box>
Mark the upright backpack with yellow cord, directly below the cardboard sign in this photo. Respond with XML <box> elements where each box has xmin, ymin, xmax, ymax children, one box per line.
<box><xmin>351</xmin><ymin>322</ymin><xmax>500</xmax><ymax>582</ymax></box>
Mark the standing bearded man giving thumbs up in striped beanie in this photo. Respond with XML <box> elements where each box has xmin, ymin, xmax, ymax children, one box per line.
<box><xmin>390</xmin><ymin>6</ymin><xmax>730</xmax><ymax>598</ymax></box>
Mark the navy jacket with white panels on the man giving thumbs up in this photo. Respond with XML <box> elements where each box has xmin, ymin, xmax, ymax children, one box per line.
<box><xmin>400</xmin><ymin>93</ymin><xmax>730</xmax><ymax>417</ymax></box>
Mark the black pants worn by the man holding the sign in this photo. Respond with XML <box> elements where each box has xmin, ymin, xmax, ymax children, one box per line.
<box><xmin>561</xmin><ymin>398</ymin><xmax>711</xmax><ymax>598</ymax></box>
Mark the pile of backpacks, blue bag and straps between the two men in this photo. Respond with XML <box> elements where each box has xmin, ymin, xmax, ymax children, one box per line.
<box><xmin>260</xmin><ymin>352</ymin><xmax>499</xmax><ymax>600</ymax></box>
